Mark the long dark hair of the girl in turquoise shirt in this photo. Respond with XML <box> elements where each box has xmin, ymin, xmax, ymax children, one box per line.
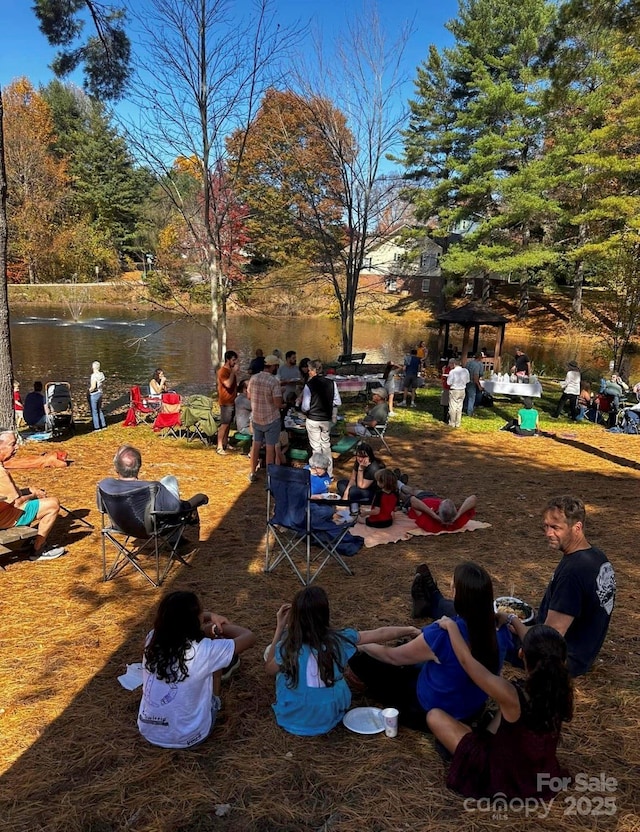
<box><xmin>281</xmin><ymin>586</ymin><xmax>347</xmax><ymax>688</ymax></box>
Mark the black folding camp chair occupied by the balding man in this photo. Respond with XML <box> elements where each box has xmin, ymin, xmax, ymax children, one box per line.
<box><xmin>97</xmin><ymin>482</ymin><xmax>208</xmax><ymax>586</ymax></box>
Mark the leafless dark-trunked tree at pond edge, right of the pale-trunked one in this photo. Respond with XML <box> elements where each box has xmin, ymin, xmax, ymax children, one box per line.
<box><xmin>296</xmin><ymin>5</ymin><xmax>412</xmax><ymax>353</ymax></box>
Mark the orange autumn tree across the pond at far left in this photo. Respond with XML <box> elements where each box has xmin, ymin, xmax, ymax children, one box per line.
<box><xmin>4</xmin><ymin>78</ymin><xmax>68</xmax><ymax>283</ymax></box>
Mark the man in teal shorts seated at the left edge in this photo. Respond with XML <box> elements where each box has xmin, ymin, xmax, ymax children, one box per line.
<box><xmin>0</xmin><ymin>428</ymin><xmax>66</xmax><ymax>560</ymax></box>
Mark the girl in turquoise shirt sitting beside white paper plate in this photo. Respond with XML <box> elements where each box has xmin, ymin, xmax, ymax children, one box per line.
<box><xmin>265</xmin><ymin>585</ymin><xmax>418</xmax><ymax>736</ymax></box>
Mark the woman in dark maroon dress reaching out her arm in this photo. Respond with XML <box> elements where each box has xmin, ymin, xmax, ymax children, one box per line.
<box><xmin>427</xmin><ymin>617</ymin><xmax>573</xmax><ymax>799</ymax></box>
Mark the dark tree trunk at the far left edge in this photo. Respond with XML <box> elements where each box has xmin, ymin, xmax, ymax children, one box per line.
<box><xmin>0</xmin><ymin>88</ymin><xmax>15</xmax><ymax>427</ymax></box>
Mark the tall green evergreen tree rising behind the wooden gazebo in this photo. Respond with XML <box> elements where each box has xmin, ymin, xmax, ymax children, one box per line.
<box><xmin>404</xmin><ymin>0</ymin><xmax>555</xmax><ymax>314</ymax></box>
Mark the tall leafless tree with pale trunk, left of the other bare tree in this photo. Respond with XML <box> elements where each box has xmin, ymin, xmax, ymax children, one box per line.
<box><xmin>126</xmin><ymin>0</ymin><xmax>300</xmax><ymax>367</ymax></box>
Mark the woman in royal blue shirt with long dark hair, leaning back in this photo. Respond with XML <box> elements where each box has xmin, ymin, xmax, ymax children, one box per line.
<box><xmin>349</xmin><ymin>562</ymin><xmax>511</xmax><ymax>731</ymax></box>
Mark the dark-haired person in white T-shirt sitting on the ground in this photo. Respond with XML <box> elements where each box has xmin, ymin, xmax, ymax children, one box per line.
<box><xmin>138</xmin><ymin>592</ymin><xmax>256</xmax><ymax>748</ymax></box>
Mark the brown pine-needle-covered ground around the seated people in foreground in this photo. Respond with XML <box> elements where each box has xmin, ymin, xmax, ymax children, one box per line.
<box><xmin>0</xmin><ymin>416</ymin><xmax>640</xmax><ymax>832</ymax></box>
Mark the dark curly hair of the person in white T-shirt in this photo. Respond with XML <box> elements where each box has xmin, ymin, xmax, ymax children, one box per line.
<box><xmin>144</xmin><ymin>592</ymin><xmax>204</xmax><ymax>683</ymax></box>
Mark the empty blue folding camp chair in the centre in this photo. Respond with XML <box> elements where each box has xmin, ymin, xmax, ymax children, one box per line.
<box><xmin>264</xmin><ymin>465</ymin><xmax>357</xmax><ymax>586</ymax></box>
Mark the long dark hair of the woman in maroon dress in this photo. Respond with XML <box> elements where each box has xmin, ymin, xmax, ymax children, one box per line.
<box><xmin>522</xmin><ymin>624</ymin><xmax>573</xmax><ymax>733</ymax></box>
